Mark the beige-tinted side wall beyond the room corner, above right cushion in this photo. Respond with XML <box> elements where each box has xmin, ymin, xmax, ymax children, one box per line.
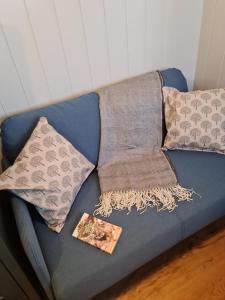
<box><xmin>195</xmin><ymin>0</ymin><xmax>225</xmax><ymax>89</ymax></box>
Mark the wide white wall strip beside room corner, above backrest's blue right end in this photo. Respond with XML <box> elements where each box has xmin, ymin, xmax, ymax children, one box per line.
<box><xmin>165</xmin><ymin>0</ymin><xmax>203</xmax><ymax>88</ymax></box>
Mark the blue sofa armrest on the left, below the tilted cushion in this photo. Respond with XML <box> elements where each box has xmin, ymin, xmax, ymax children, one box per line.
<box><xmin>2</xmin><ymin>158</ymin><xmax>54</xmax><ymax>299</ymax></box>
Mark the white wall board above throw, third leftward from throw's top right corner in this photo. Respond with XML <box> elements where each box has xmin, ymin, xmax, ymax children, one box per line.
<box><xmin>104</xmin><ymin>0</ymin><xmax>129</xmax><ymax>81</ymax></box>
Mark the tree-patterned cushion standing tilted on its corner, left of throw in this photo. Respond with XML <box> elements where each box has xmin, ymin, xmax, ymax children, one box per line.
<box><xmin>0</xmin><ymin>117</ymin><xmax>94</xmax><ymax>232</ymax></box>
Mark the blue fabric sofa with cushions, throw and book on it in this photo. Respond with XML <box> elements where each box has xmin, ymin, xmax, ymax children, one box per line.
<box><xmin>1</xmin><ymin>69</ymin><xmax>225</xmax><ymax>300</ymax></box>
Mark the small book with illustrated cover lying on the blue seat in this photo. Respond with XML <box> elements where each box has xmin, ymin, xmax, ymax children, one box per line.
<box><xmin>72</xmin><ymin>213</ymin><xmax>122</xmax><ymax>254</ymax></box>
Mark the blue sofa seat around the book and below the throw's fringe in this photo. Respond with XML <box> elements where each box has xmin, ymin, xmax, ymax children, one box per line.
<box><xmin>29</xmin><ymin>151</ymin><xmax>225</xmax><ymax>299</ymax></box>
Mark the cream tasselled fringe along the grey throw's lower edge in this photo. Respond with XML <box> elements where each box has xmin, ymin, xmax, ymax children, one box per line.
<box><xmin>94</xmin><ymin>184</ymin><xmax>194</xmax><ymax>217</ymax></box>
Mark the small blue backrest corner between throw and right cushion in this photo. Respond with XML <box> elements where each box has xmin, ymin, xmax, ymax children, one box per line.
<box><xmin>160</xmin><ymin>68</ymin><xmax>188</xmax><ymax>92</ymax></box>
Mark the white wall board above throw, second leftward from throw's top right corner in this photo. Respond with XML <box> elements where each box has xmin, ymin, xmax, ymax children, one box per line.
<box><xmin>126</xmin><ymin>0</ymin><xmax>146</xmax><ymax>75</ymax></box>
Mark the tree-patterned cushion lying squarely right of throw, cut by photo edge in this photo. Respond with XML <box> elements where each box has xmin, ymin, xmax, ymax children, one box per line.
<box><xmin>163</xmin><ymin>87</ymin><xmax>225</xmax><ymax>153</ymax></box>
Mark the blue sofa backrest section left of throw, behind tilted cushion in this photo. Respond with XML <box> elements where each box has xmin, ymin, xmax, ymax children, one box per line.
<box><xmin>1</xmin><ymin>93</ymin><xmax>100</xmax><ymax>164</ymax></box>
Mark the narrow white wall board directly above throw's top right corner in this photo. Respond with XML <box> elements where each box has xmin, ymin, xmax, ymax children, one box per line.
<box><xmin>145</xmin><ymin>0</ymin><xmax>166</xmax><ymax>70</ymax></box>
